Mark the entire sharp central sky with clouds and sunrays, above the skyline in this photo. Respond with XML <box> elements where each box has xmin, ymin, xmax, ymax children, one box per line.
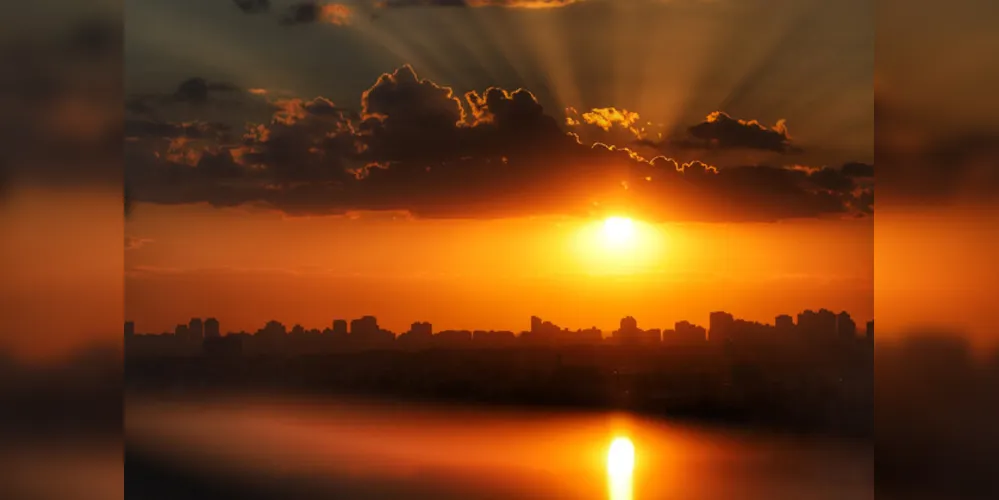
<box><xmin>124</xmin><ymin>0</ymin><xmax>874</xmax><ymax>338</ymax></box>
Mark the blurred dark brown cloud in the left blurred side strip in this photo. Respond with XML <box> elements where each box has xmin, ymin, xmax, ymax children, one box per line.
<box><xmin>0</xmin><ymin>14</ymin><xmax>123</xmax><ymax>189</ymax></box>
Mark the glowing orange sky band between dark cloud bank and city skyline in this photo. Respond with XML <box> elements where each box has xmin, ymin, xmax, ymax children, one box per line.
<box><xmin>125</xmin><ymin>205</ymin><xmax>873</xmax><ymax>332</ymax></box>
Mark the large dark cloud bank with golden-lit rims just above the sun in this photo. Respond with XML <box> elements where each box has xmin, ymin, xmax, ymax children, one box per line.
<box><xmin>125</xmin><ymin>66</ymin><xmax>865</xmax><ymax>221</ymax></box>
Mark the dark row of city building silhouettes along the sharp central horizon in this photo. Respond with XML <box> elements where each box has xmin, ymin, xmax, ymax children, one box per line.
<box><xmin>124</xmin><ymin>309</ymin><xmax>874</xmax><ymax>356</ymax></box>
